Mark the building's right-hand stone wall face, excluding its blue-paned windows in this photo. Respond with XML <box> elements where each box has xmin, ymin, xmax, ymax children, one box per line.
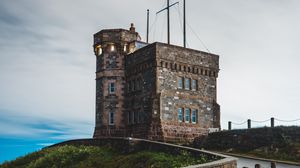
<box><xmin>156</xmin><ymin>43</ymin><xmax>220</xmax><ymax>142</ymax></box>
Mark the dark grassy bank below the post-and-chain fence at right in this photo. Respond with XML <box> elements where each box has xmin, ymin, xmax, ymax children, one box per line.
<box><xmin>194</xmin><ymin>126</ymin><xmax>300</xmax><ymax>162</ymax></box>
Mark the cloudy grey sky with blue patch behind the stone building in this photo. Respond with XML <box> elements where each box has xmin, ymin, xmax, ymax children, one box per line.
<box><xmin>0</xmin><ymin>0</ymin><xmax>300</xmax><ymax>163</ymax></box>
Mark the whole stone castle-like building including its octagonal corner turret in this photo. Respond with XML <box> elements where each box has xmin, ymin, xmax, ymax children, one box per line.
<box><xmin>94</xmin><ymin>25</ymin><xmax>220</xmax><ymax>142</ymax></box>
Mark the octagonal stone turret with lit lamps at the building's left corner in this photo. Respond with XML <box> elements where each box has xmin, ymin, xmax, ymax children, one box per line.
<box><xmin>93</xmin><ymin>24</ymin><xmax>140</xmax><ymax>137</ymax></box>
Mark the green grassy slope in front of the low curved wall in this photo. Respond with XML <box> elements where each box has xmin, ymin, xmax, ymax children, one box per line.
<box><xmin>0</xmin><ymin>146</ymin><xmax>211</xmax><ymax>168</ymax></box>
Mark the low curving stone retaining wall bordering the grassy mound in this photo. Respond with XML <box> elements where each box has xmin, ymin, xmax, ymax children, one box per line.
<box><xmin>48</xmin><ymin>138</ymin><xmax>237</xmax><ymax>168</ymax></box>
